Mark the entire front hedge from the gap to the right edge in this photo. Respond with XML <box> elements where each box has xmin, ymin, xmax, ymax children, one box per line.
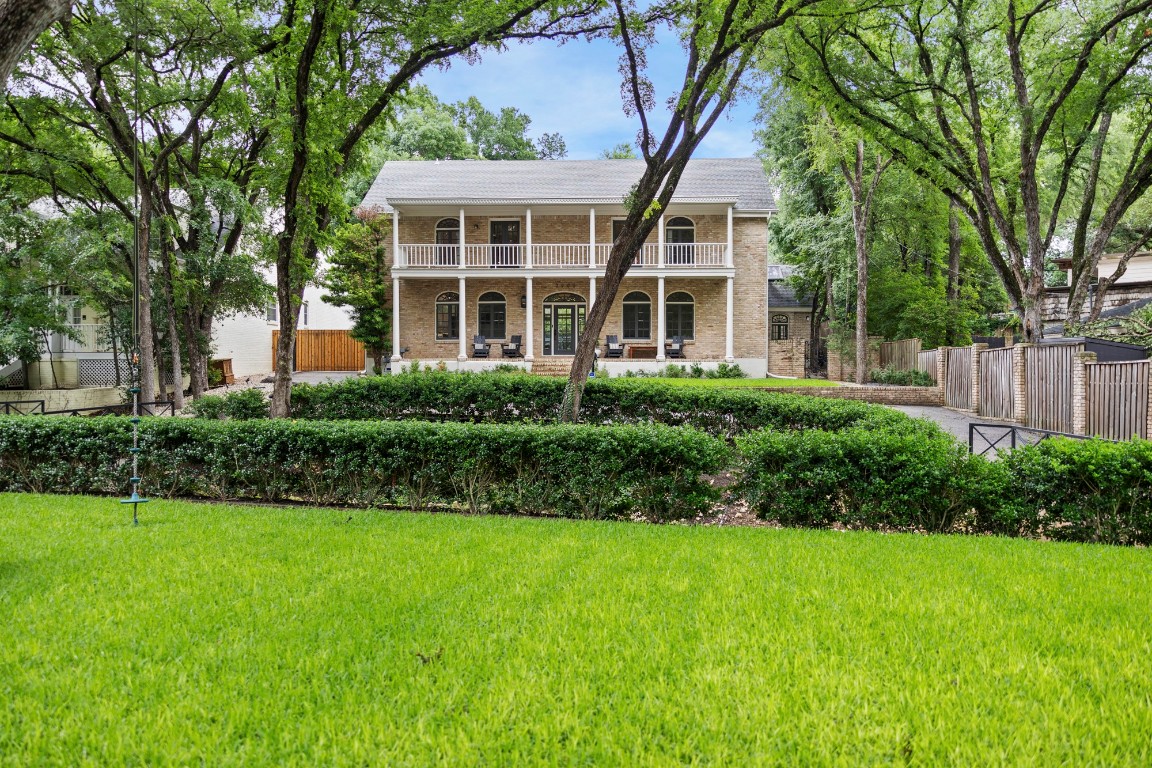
<box><xmin>736</xmin><ymin>427</ymin><xmax>1152</xmax><ymax>546</ymax></box>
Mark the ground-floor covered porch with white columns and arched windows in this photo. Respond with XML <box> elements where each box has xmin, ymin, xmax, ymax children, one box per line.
<box><xmin>392</xmin><ymin>274</ymin><xmax>735</xmax><ymax>370</ymax></box>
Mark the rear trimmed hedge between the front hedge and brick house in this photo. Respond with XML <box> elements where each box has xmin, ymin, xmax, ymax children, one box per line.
<box><xmin>291</xmin><ymin>373</ymin><xmax>912</xmax><ymax>436</ymax></box>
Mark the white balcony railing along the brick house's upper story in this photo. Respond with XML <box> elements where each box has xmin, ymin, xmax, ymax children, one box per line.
<box><xmin>401</xmin><ymin>243</ymin><xmax>728</xmax><ymax>269</ymax></box>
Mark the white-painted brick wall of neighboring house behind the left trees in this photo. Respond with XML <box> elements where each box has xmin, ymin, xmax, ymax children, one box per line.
<box><xmin>212</xmin><ymin>265</ymin><xmax>363</xmax><ymax>377</ymax></box>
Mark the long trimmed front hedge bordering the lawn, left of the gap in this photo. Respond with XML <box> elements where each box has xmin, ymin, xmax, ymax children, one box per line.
<box><xmin>0</xmin><ymin>417</ymin><xmax>729</xmax><ymax>519</ymax></box>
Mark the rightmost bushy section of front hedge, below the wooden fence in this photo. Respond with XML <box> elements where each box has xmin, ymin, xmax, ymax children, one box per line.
<box><xmin>1002</xmin><ymin>438</ymin><xmax>1152</xmax><ymax>546</ymax></box>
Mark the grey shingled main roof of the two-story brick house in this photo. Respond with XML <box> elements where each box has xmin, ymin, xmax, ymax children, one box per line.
<box><xmin>363</xmin><ymin>158</ymin><xmax>776</xmax><ymax>213</ymax></box>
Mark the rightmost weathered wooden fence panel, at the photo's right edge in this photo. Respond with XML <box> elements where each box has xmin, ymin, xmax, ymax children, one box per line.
<box><xmin>1085</xmin><ymin>360</ymin><xmax>1149</xmax><ymax>440</ymax></box>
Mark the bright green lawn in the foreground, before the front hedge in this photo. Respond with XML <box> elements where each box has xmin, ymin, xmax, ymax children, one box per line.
<box><xmin>0</xmin><ymin>495</ymin><xmax>1152</xmax><ymax>766</ymax></box>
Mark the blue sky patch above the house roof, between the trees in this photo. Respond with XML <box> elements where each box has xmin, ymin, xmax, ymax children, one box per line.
<box><xmin>420</xmin><ymin>32</ymin><xmax>757</xmax><ymax>160</ymax></box>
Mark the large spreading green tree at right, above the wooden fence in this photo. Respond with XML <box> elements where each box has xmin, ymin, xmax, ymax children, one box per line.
<box><xmin>779</xmin><ymin>0</ymin><xmax>1152</xmax><ymax>339</ymax></box>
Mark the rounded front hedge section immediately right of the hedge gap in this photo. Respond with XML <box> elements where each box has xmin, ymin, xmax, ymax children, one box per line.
<box><xmin>736</xmin><ymin>421</ymin><xmax>1001</xmax><ymax>532</ymax></box>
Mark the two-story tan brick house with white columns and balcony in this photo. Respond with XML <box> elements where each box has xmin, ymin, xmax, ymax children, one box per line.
<box><xmin>363</xmin><ymin>158</ymin><xmax>808</xmax><ymax>375</ymax></box>
